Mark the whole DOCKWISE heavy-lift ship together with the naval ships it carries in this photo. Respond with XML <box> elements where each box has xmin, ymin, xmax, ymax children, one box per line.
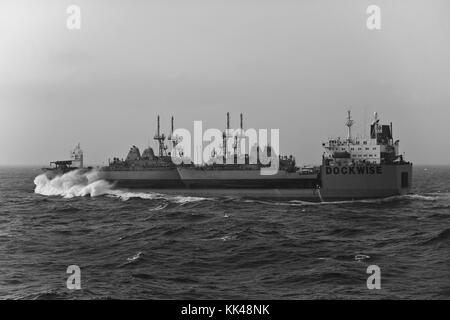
<box><xmin>42</xmin><ymin>111</ymin><xmax>412</xmax><ymax>201</ymax></box>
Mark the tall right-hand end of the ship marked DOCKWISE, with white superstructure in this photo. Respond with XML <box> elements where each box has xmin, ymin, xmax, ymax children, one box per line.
<box><xmin>318</xmin><ymin>111</ymin><xmax>412</xmax><ymax>200</ymax></box>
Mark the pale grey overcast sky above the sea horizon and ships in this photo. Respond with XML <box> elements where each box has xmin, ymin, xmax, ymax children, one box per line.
<box><xmin>0</xmin><ymin>0</ymin><xmax>450</xmax><ymax>165</ymax></box>
